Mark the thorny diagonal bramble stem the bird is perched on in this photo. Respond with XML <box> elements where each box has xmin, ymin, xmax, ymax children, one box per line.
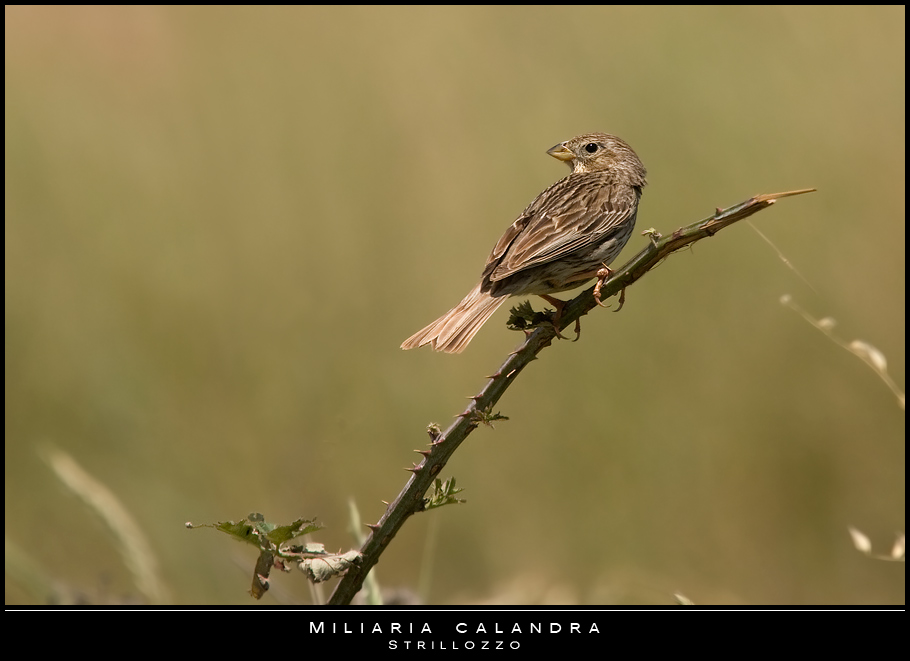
<box><xmin>328</xmin><ymin>188</ymin><xmax>815</xmax><ymax>606</ymax></box>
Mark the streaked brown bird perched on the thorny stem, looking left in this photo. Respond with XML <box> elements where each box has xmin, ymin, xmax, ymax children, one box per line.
<box><xmin>401</xmin><ymin>133</ymin><xmax>647</xmax><ymax>353</ymax></box>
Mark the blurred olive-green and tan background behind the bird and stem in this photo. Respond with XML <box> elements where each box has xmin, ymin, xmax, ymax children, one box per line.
<box><xmin>5</xmin><ymin>7</ymin><xmax>905</xmax><ymax>605</ymax></box>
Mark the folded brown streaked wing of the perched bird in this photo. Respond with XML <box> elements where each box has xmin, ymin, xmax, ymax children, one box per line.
<box><xmin>484</xmin><ymin>173</ymin><xmax>636</xmax><ymax>281</ymax></box>
